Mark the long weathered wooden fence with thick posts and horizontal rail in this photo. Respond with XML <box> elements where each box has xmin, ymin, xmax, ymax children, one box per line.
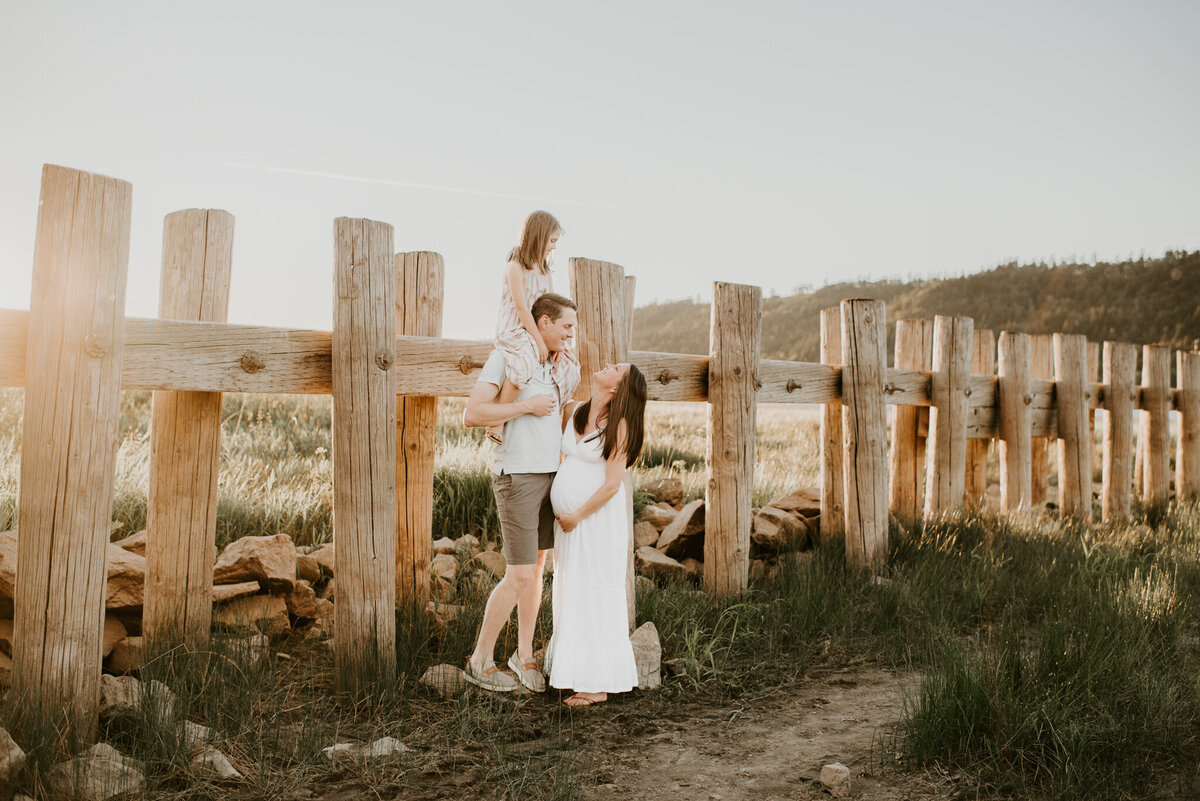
<box><xmin>0</xmin><ymin>165</ymin><xmax>1200</xmax><ymax>736</ymax></box>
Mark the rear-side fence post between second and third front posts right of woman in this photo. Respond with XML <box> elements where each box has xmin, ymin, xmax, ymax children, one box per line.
<box><xmin>888</xmin><ymin>319</ymin><xmax>934</xmax><ymax>523</ymax></box>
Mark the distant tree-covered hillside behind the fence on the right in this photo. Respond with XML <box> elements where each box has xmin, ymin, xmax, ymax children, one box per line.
<box><xmin>632</xmin><ymin>251</ymin><xmax>1200</xmax><ymax>362</ymax></box>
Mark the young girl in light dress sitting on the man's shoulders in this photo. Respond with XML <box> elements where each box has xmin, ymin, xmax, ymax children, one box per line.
<box><xmin>487</xmin><ymin>211</ymin><xmax>580</xmax><ymax>442</ymax></box>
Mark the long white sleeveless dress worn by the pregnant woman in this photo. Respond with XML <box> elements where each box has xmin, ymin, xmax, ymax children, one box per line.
<box><xmin>546</xmin><ymin>421</ymin><xmax>637</xmax><ymax>693</ymax></box>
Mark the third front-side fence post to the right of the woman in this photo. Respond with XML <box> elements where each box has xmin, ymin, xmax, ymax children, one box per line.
<box><xmin>925</xmin><ymin>315</ymin><xmax>974</xmax><ymax>518</ymax></box>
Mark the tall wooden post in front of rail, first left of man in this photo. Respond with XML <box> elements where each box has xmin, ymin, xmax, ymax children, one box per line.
<box><xmin>332</xmin><ymin>217</ymin><xmax>396</xmax><ymax>692</ymax></box>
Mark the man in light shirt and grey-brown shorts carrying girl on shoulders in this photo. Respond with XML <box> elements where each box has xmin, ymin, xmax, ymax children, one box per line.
<box><xmin>462</xmin><ymin>293</ymin><xmax>577</xmax><ymax>693</ymax></box>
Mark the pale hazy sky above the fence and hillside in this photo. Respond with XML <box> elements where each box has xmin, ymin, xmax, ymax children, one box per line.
<box><xmin>0</xmin><ymin>0</ymin><xmax>1200</xmax><ymax>338</ymax></box>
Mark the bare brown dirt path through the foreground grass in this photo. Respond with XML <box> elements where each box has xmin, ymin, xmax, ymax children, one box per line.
<box><xmin>583</xmin><ymin>668</ymin><xmax>949</xmax><ymax>801</ymax></box>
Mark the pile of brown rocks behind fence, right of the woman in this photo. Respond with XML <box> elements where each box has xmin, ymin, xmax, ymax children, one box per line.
<box><xmin>634</xmin><ymin>478</ymin><xmax>821</xmax><ymax>580</ymax></box>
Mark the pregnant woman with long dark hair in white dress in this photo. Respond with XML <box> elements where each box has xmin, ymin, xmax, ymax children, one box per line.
<box><xmin>546</xmin><ymin>363</ymin><xmax>646</xmax><ymax>706</ymax></box>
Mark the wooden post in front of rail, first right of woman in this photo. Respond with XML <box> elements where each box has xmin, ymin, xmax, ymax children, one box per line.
<box><xmin>704</xmin><ymin>282</ymin><xmax>762</xmax><ymax>596</ymax></box>
